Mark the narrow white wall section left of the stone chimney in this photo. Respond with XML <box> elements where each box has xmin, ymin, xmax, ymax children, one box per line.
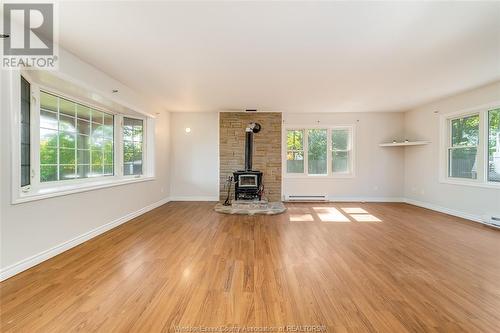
<box><xmin>170</xmin><ymin>112</ymin><xmax>219</xmax><ymax>201</ymax></box>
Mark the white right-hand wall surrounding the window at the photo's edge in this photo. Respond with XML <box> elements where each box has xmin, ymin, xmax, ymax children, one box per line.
<box><xmin>404</xmin><ymin>82</ymin><xmax>500</xmax><ymax>219</ymax></box>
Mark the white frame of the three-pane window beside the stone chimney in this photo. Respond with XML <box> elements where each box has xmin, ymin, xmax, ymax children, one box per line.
<box><xmin>282</xmin><ymin>125</ymin><xmax>356</xmax><ymax>179</ymax></box>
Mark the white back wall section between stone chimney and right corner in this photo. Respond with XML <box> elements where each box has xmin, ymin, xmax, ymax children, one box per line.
<box><xmin>283</xmin><ymin>112</ymin><xmax>404</xmax><ymax>201</ymax></box>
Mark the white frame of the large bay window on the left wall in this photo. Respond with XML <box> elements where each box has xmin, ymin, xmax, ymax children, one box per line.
<box><xmin>10</xmin><ymin>72</ymin><xmax>155</xmax><ymax>204</ymax></box>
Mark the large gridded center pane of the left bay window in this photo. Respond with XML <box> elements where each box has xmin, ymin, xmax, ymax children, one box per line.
<box><xmin>40</xmin><ymin>91</ymin><xmax>114</xmax><ymax>182</ymax></box>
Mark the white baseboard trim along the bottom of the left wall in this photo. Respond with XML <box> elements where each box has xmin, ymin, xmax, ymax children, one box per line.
<box><xmin>0</xmin><ymin>198</ymin><xmax>170</xmax><ymax>281</ymax></box>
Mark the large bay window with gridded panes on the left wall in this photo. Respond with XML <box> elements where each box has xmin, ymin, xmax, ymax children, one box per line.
<box><xmin>13</xmin><ymin>71</ymin><xmax>154</xmax><ymax>204</ymax></box>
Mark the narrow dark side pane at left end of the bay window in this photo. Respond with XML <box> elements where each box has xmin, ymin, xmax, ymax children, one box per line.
<box><xmin>21</xmin><ymin>77</ymin><xmax>31</xmax><ymax>187</ymax></box>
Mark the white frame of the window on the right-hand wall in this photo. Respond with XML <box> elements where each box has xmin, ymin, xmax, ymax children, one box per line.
<box><xmin>439</xmin><ymin>101</ymin><xmax>500</xmax><ymax>188</ymax></box>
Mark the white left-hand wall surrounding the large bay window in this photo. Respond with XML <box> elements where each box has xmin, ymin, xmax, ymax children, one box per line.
<box><xmin>0</xmin><ymin>50</ymin><xmax>170</xmax><ymax>277</ymax></box>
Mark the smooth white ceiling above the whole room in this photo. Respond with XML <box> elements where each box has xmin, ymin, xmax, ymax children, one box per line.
<box><xmin>59</xmin><ymin>1</ymin><xmax>500</xmax><ymax>112</ymax></box>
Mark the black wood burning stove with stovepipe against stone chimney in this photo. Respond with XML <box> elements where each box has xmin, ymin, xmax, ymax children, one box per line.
<box><xmin>233</xmin><ymin>123</ymin><xmax>263</xmax><ymax>200</ymax></box>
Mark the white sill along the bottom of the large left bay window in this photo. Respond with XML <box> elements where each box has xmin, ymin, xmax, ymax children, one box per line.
<box><xmin>12</xmin><ymin>176</ymin><xmax>155</xmax><ymax>205</ymax></box>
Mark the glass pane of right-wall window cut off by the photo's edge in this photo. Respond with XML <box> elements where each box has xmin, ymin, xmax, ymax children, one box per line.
<box><xmin>488</xmin><ymin>109</ymin><xmax>500</xmax><ymax>182</ymax></box>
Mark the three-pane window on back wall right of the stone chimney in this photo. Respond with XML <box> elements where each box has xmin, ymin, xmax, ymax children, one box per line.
<box><xmin>285</xmin><ymin>126</ymin><xmax>354</xmax><ymax>177</ymax></box>
